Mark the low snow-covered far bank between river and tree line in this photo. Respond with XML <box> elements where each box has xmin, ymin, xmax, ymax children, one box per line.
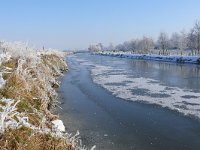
<box><xmin>95</xmin><ymin>51</ymin><xmax>200</xmax><ymax>64</ymax></box>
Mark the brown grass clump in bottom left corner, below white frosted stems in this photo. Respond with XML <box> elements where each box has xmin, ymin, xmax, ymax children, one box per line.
<box><xmin>0</xmin><ymin>127</ymin><xmax>74</xmax><ymax>150</ymax></box>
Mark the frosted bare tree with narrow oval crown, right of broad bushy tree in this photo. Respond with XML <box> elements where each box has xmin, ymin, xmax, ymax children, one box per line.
<box><xmin>158</xmin><ymin>32</ymin><xmax>169</xmax><ymax>55</ymax></box>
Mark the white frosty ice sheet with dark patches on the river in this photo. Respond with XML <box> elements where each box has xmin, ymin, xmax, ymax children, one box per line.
<box><xmin>91</xmin><ymin>62</ymin><xmax>200</xmax><ymax>118</ymax></box>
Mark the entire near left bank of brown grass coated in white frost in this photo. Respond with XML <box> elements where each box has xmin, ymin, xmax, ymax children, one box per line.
<box><xmin>0</xmin><ymin>42</ymin><xmax>92</xmax><ymax>150</ymax></box>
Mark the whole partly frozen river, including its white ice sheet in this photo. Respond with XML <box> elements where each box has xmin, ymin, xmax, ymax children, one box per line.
<box><xmin>59</xmin><ymin>53</ymin><xmax>200</xmax><ymax>150</ymax></box>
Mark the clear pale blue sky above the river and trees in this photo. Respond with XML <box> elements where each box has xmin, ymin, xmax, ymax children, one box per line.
<box><xmin>0</xmin><ymin>0</ymin><xmax>200</xmax><ymax>49</ymax></box>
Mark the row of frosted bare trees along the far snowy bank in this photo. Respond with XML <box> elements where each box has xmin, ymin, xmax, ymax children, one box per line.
<box><xmin>88</xmin><ymin>21</ymin><xmax>200</xmax><ymax>55</ymax></box>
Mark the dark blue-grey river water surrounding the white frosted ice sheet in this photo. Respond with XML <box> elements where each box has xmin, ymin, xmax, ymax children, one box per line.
<box><xmin>55</xmin><ymin>54</ymin><xmax>200</xmax><ymax>150</ymax></box>
